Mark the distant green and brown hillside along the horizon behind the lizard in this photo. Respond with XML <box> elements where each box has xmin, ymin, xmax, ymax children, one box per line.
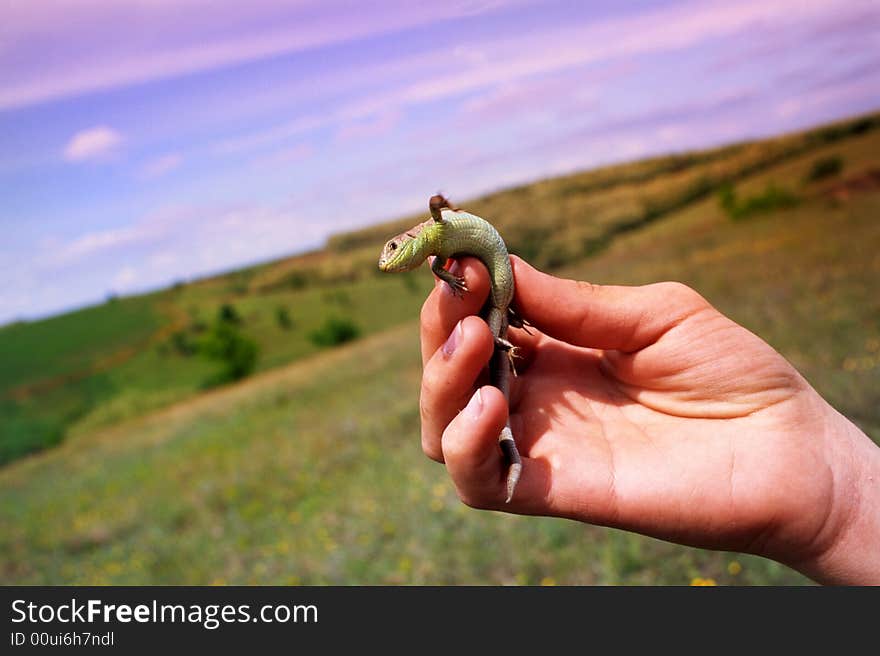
<box><xmin>0</xmin><ymin>115</ymin><xmax>880</xmax><ymax>465</ymax></box>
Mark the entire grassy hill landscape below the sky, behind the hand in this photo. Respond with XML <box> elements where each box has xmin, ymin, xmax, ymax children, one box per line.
<box><xmin>0</xmin><ymin>111</ymin><xmax>880</xmax><ymax>584</ymax></box>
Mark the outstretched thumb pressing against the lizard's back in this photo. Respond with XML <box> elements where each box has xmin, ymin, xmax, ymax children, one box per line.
<box><xmin>511</xmin><ymin>256</ymin><xmax>711</xmax><ymax>352</ymax></box>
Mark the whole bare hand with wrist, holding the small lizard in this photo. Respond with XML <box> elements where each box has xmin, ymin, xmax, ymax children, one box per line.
<box><xmin>421</xmin><ymin>257</ymin><xmax>880</xmax><ymax>582</ymax></box>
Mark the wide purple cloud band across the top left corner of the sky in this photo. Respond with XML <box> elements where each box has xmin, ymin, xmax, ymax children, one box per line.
<box><xmin>0</xmin><ymin>0</ymin><xmax>524</xmax><ymax>109</ymax></box>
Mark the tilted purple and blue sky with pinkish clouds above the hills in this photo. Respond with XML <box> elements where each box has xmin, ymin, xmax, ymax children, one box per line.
<box><xmin>0</xmin><ymin>0</ymin><xmax>880</xmax><ymax>324</ymax></box>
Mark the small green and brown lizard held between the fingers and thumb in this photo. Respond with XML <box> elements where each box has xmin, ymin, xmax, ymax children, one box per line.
<box><xmin>379</xmin><ymin>195</ymin><xmax>524</xmax><ymax>502</ymax></box>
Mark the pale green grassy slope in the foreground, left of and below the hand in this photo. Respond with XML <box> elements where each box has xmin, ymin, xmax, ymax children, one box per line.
<box><xmin>0</xmin><ymin>323</ymin><xmax>802</xmax><ymax>584</ymax></box>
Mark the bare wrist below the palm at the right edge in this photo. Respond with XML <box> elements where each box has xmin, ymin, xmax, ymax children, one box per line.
<box><xmin>790</xmin><ymin>406</ymin><xmax>880</xmax><ymax>585</ymax></box>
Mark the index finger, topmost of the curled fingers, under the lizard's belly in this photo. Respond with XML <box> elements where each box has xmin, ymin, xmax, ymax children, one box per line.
<box><xmin>420</xmin><ymin>257</ymin><xmax>489</xmax><ymax>364</ymax></box>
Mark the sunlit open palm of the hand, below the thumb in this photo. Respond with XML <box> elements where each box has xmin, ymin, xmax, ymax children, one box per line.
<box><xmin>511</xmin><ymin>312</ymin><xmax>830</xmax><ymax>550</ymax></box>
